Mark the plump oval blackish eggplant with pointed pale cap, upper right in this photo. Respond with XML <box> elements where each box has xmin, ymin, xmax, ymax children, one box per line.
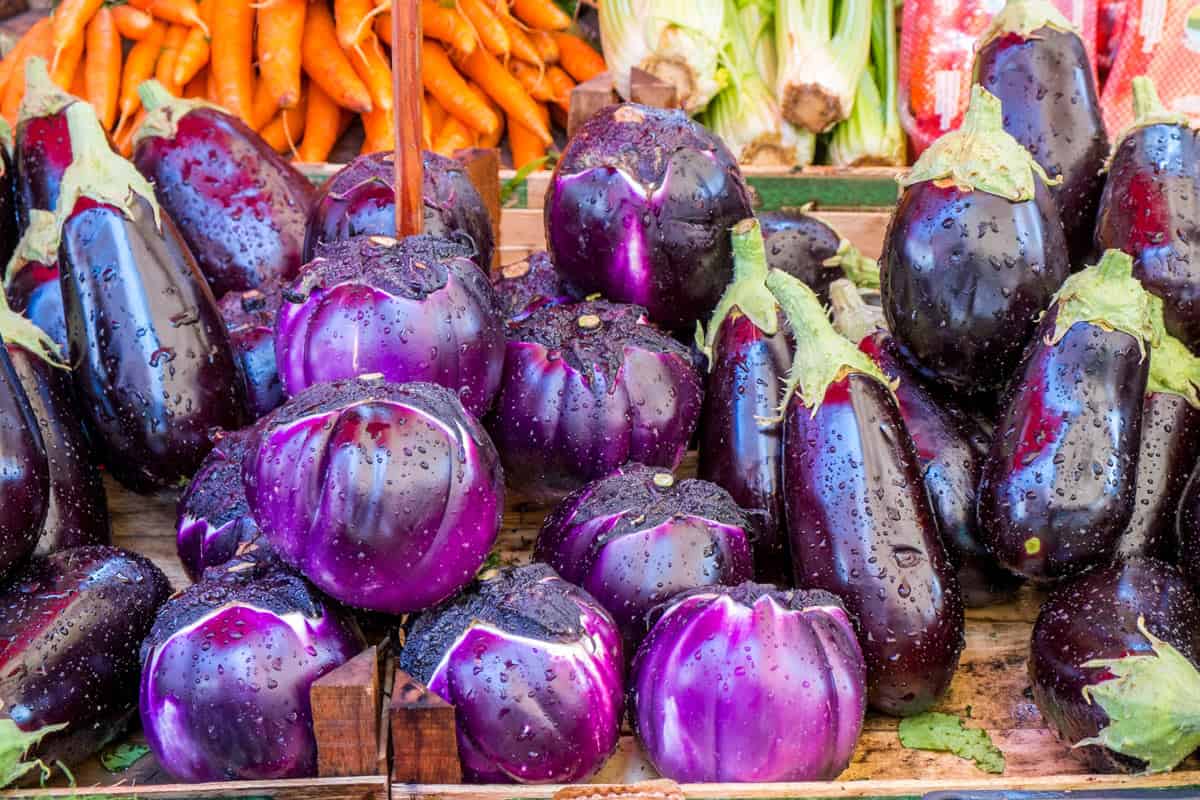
<box><xmin>881</xmin><ymin>86</ymin><xmax>1070</xmax><ymax>393</ymax></box>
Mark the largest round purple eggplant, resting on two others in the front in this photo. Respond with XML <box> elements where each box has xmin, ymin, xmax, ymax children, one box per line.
<box><xmin>242</xmin><ymin>378</ymin><xmax>504</xmax><ymax>614</ymax></box>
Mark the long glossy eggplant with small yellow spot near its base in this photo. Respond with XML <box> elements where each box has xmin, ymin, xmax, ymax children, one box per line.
<box><xmin>979</xmin><ymin>249</ymin><xmax>1156</xmax><ymax>581</ymax></box>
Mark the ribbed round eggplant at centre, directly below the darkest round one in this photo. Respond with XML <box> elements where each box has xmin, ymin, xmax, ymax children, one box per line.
<box><xmin>488</xmin><ymin>300</ymin><xmax>703</xmax><ymax>501</ymax></box>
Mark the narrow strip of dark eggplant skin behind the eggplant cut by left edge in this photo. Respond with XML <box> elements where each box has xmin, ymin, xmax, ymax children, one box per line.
<box><xmin>7</xmin><ymin>345</ymin><xmax>113</xmax><ymax>555</ymax></box>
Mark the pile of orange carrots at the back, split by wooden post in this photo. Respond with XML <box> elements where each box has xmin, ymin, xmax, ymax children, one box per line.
<box><xmin>0</xmin><ymin>0</ymin><xmax>605</xmax><ymax>167</ymax></box>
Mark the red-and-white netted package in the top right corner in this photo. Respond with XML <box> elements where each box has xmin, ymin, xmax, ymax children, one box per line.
<box><xmin>1100</xmin><ymin>0</ymin><xmax>1200</xmax><ymax>131</ymax></box>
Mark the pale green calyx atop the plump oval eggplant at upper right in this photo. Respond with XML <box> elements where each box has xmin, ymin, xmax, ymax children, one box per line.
<box><xmin>899</xmin><ymin>84</ymin><xmax>1062</xmax><ymax>203</ymax></box>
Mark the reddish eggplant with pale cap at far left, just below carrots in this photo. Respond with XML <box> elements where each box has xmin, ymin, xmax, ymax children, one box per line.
<box><xmin>13</xmin><ymin>58</ymin><xmax>78</xmax><ymax>230</ymax></box>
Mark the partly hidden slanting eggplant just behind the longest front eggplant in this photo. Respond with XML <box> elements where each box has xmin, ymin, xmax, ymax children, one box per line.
<box><xmin>829</xmin><ymin>281</ymin><xmax>1021</xmax><ymax>608</ymax></box>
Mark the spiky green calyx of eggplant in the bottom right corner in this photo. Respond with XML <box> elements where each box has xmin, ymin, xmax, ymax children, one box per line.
<box><xmin>1075</xmin><ymin>616</ymin><xmax>1200</xmax><ymax>772</ymax></box>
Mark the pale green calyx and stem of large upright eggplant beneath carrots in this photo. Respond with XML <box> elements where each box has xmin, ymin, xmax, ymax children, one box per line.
<box><xmin>55</xmin><ymin>103</ymin><xmax>162</xmax><ymax>230</ymax></box>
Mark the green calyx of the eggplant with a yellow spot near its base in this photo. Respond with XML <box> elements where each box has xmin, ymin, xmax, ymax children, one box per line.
<box><xmin>1050</xmin><ymin>249</ymin><xmax>1160</xmax><ymax>356</ymax></box>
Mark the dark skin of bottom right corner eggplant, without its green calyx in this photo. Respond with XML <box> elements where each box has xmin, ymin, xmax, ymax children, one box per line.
<box><xmin>1030</xmin><ymin>558</ymin><xmax>1200</xmax><ymax>772</ymax></box>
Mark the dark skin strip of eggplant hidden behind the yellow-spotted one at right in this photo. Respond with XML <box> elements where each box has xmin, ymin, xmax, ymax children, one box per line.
<box><xmin>1116</xmin><ymin>392</ymin><xmax>1200</xmax><ymax>563</ymax></box>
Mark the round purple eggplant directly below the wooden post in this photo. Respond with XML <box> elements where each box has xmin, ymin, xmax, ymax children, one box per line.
<box><xmin>275</xmin><ymin>236</ymin><xmax>504</xmax><ymax>416</ymax></box>
